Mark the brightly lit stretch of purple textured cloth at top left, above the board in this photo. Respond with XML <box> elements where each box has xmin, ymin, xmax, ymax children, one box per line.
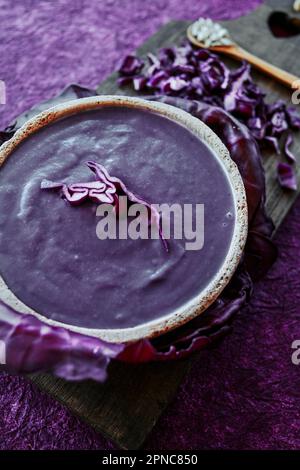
<box><xmin>0</xmin><ymin>0</ymin><xmax>262</xmax><ymax>128</ymax></box>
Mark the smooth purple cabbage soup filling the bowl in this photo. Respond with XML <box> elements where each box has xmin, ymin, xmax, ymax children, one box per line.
<box><xmin>0</xmin><ymin>106</ymin><xmax>235</xmax><ymax>329</ymax></box>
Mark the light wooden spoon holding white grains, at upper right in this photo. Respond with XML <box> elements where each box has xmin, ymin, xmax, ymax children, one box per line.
<box><xmin>187</xmin><ymin>24</ymin><xmax>300</xmax><ymax>89</ymax></box>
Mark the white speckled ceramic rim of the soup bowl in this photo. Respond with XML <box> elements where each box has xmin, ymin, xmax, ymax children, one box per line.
<box><xmin>0</xmin><ymin>95</ymin><xmax>248</xmax><ymax>343</ymax></box>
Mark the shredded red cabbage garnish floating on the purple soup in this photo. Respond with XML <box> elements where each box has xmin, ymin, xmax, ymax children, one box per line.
<box><xmin>41</xmin><ymin>161</ymin><xmax>169</xmax><ymax>251</ymax></box>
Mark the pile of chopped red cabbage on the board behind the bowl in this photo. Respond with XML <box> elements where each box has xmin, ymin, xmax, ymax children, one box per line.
<box><xmin>118</xmin><ymin>43</ymin><xmax>300</xmax><ymax>189</ymax></box>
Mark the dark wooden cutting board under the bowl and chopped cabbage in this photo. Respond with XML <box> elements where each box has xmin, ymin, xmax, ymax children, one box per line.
<box><xmin>31</xmin><ymin>1</ymin><xmax>300</xmax><ymax>449</ymax></box>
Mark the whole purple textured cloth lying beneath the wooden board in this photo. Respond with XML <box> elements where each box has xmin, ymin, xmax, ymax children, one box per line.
<box><xmin>0</xmin><ymin>0</ymin><xmax>300</xmax><ymax>450</ymax></box>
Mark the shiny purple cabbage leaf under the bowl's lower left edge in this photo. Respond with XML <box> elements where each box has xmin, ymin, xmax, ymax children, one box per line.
<box><xmin>0</xmin><ymin>301</ymin><xmax>124</xmax><ymax>382</ymax></box>
